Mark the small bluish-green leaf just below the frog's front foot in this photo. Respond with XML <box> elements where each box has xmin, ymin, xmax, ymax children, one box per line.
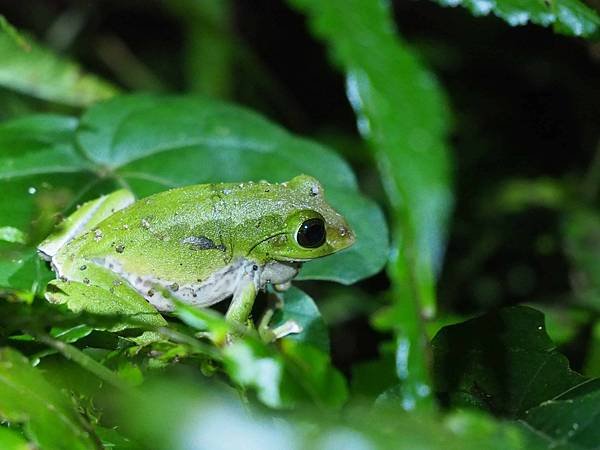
<box><xmin>269</xmin><ymin>287</ymin><xmax>329</xmax><ymax>353</ymax></box>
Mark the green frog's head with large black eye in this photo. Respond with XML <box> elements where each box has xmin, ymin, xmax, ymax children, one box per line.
<box><xmin>250</xmin><ymin>175</ymin><xmax>355</xmax><ymax>261</ymax></box>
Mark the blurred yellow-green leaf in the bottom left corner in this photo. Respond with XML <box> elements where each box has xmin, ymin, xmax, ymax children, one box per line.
<box><xmin>0</xmin><ymin>348</ymin><xmax>100</xmax><ymax>450</ymax></box>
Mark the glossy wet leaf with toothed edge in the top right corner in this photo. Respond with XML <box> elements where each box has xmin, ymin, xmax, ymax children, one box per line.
<box><xmin>436</xmin><ymin>0</ymin><xmax>600</xmax><ymax>37</ymax></box>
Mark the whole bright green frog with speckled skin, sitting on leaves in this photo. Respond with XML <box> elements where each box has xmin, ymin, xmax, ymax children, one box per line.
<box><xmin>38</xmin><ymin>175</ymin><xmax>355</xmax><ymax>339</ymax></box>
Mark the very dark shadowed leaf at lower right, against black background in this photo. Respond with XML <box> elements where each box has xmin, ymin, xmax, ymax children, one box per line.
<box><xmin>432</xmin><ymin>306</ymin><xmax>585</xmax><ymax>417</ymax></box>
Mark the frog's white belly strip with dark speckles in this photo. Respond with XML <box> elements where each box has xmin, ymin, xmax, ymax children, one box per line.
<box><xmin>93</xmin><ymin>257</ymin><xmax>299</xmax><ymax>312</ymax></box>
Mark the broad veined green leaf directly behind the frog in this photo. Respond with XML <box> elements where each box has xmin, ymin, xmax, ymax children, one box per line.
<box><xmin>0</xmin><ymin>96</ymin><xmax>388</xmax><ymax>288</ymax></box>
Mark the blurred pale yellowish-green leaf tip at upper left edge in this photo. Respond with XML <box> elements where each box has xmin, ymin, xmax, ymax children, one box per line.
<box><xmin>0</xmin><ymin>33</ymin><xmax>117</xmax><ymax>106</ymax></box>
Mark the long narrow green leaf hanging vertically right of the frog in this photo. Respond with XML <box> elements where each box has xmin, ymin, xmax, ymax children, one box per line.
<box><xmin>290</xmin><ymin>0</ymin><xmax>452</xmax><ymax>410</ymax></box>
